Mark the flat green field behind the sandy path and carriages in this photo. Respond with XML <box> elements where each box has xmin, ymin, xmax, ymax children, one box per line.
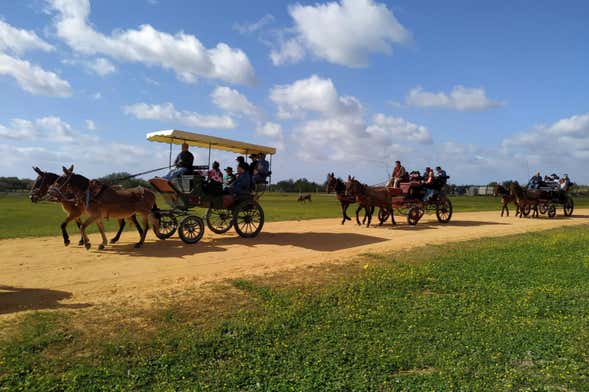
<box><xmin>0</xmin><ymin>193</ymin><xmax>589</xmax><ymax>239</ymax></box>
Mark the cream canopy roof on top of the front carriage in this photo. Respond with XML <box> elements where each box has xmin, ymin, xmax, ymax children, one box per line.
<box><xmin>146</xmin><ymin>129</ymin><xmax>276</xmax><ymax>155</ymax></box>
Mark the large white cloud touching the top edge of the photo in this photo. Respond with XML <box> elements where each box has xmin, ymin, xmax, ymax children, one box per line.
<box><xmin>271</xmin><ymin>0</ymin><xmax>410</xmax><ymax>67</ymax></box>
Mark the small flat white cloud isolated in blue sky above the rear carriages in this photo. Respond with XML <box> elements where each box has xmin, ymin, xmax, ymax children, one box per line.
<box><xmin>405</xmin><ymin>85</ymin><xmax>504</xmax><ymax>111</ymax></box>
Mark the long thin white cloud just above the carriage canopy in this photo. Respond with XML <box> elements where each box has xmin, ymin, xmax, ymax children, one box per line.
<box><xmin>123</xmin><ymin>102</ymin><xmax>235</xmax><ymax>129</ymax></box>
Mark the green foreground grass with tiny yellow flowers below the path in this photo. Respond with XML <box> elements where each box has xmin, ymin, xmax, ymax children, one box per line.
<box><xmin>0</xmin><ymin>226</ymin><xmax>589</xmax><ymax>391</ymax></box>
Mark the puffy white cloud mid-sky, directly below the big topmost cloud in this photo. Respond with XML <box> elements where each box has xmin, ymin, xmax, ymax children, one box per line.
<box><xmin>270</xmin><ymin>75</ymin><xmax>362</xmax><ymax>119</ymax></box>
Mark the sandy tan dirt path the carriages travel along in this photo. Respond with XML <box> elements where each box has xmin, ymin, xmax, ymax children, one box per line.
<box><xmin>0</xmin><ymin>210</ymin><xmax>589</xmax><ymax>315</ymax></box>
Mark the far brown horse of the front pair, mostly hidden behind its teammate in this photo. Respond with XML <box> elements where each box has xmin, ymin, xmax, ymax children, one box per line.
<box><xmin>29</xmin><ymin>166</ymin><xmax>142</xmax><ymax>246</ymax></box>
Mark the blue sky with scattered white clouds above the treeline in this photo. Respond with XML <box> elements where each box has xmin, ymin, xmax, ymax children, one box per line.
<box><xmin>0</xmin><ymin>0</ymin><xmax>589</xmax><ymax>184</ymax></box>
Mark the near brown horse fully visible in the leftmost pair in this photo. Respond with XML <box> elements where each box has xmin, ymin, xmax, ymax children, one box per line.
<box><xmin>48</xmin><ymin>165</ymin><xmax>157</xmax><ymax>249</ymax></box>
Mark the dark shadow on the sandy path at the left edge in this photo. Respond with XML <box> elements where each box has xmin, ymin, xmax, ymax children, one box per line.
<box><xmin>0</xmin><ymin>285</ymin><xmax>91</xmax><ymax>314</ymax></box>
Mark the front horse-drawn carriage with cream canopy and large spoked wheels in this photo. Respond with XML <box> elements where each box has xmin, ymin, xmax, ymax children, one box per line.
<box><xmin>147</xmin><ymin>130</ymin><xmax>276</xmax><ymax>244</ymax></box>
